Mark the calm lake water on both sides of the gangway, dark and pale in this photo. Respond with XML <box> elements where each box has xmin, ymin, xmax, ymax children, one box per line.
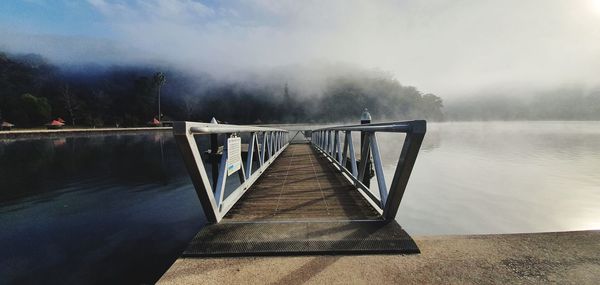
<box><xmin>0</xmin><ymin>122</ymin><xmax>600</xmax><ymax>284</ymax></box>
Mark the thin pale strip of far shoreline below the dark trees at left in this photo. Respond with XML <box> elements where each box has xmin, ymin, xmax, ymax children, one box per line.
<box><xmin>0</xmin><ymin>127</ymin><xmax>172</xmax><ymax>139</ymax></box>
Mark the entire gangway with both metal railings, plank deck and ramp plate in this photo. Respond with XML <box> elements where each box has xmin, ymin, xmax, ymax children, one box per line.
<box><xmin>173</xmin><ymin>121</ymin><xmax>426</xmax><ymax>257</ymax></box>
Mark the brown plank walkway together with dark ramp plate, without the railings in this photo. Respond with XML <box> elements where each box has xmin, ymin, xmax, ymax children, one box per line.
<box><xmin>183</xmin><ymin>144</ymin><xmax>419</xmax><ymax>257</ymax></box>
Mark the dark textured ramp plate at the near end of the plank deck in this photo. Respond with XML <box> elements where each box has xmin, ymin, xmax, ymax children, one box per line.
<box><xmin>183</xmin><ymin>221</ymin><xmax>419</xmax><ymax>257</ymax></box>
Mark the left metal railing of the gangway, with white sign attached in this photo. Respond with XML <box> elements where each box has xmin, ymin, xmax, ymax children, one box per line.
<box><xmin>173</xmin><ymin>122</ymin><xmax>289</xmax><ymax>223</ymax></box>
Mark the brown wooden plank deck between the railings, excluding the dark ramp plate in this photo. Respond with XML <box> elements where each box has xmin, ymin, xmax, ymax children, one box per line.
<box><xmin>223</xmin><ymin>144</ymin><xmax>380</xmax><ymax>222</ymax></box>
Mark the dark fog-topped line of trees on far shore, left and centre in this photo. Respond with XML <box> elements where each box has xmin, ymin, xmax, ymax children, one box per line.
<box><xmin>0</xmin><ymin>50</ymin><xmax>443</xmax><ymax>127</ymax></box>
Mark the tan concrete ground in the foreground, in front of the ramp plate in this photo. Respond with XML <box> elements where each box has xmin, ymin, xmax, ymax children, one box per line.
<box><xmin>159</xmin><ymin>231</ymin><xmax>600</xmax><ymax>285</ymax></box>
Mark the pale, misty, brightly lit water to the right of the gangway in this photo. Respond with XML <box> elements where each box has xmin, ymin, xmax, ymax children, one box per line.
<box><xmin>380</xmin><ymin>122</ymin><xmax>600</xmax><ymax>234</ymax></box>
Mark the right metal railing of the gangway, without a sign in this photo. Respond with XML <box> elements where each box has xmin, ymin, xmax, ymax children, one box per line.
<box><xmin>311</xmin><ymin>120</ymin><xmax>427</xmax><ymax>220</ymax></box>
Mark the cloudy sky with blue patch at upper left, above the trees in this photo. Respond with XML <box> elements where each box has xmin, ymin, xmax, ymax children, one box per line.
<box><xmin>0</xmin><ymin>0</ymin><xmax>600</xmax><ymax>98</ymax></box>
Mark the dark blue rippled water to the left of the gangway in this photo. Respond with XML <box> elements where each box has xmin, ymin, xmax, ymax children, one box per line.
<box><xmin>0</xmin><ymin>133</ymin><xmax>205</xmax><ymax>284</ymax></box>
